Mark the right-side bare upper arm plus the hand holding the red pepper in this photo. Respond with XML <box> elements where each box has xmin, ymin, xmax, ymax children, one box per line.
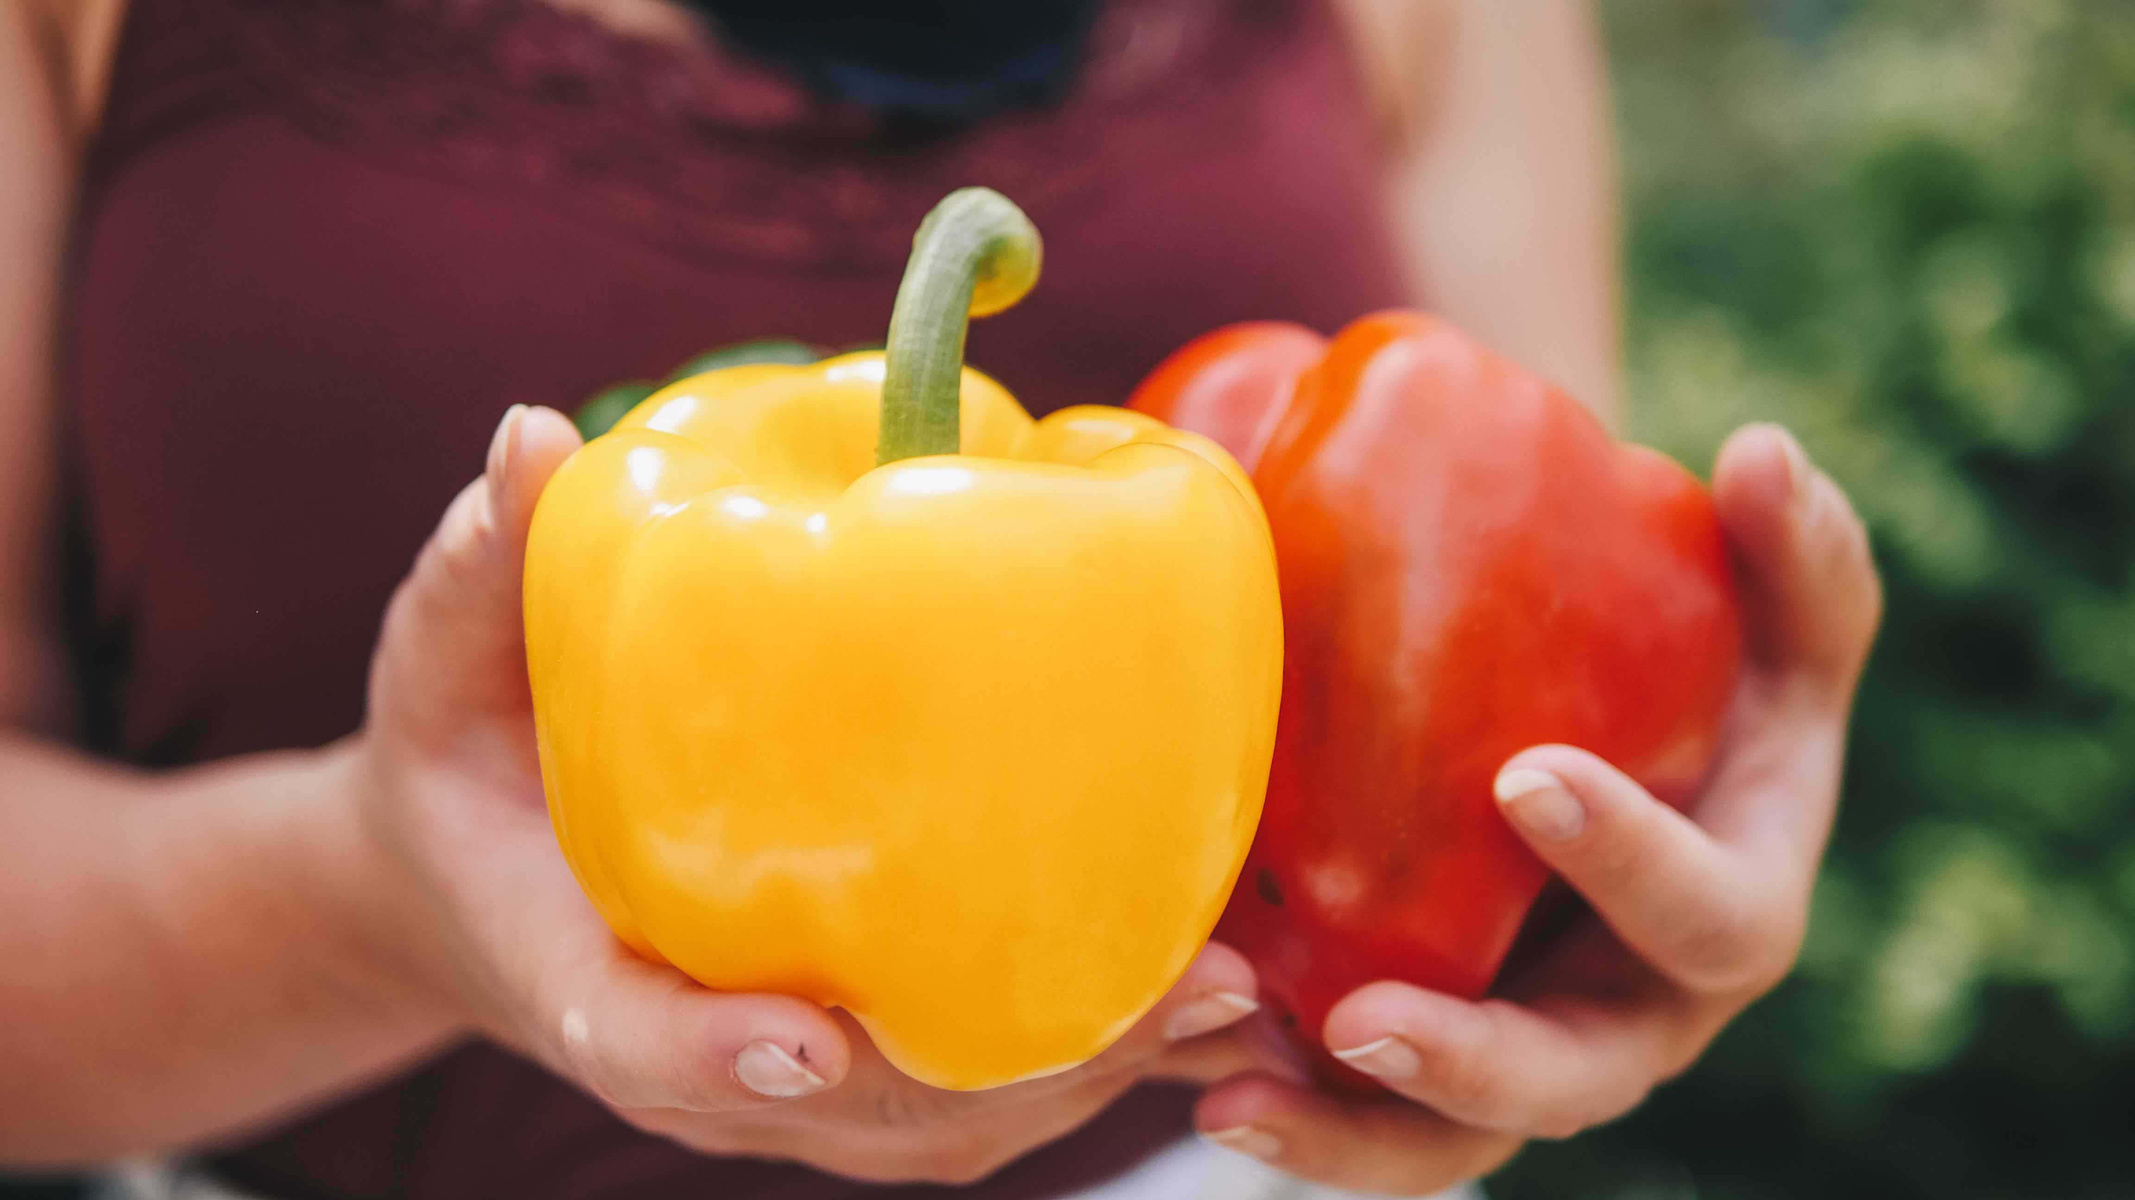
<box><xmin>1168</xmin><ymin>9</ymin><xmax>1881</xmax><ymax>1194</ymax></box>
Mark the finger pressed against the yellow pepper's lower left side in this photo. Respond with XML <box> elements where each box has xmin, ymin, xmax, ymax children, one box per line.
<box><xmin>536</xmin><ymin>896</ymin><xmax>852</xmax><ymax>1112</ymax></box>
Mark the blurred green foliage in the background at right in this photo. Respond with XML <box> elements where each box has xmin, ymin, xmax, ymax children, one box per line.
<box><xmin>1490</xmin><ymin>0</ymin><xmax>2135</xmax><ymax>1200</ymax></box>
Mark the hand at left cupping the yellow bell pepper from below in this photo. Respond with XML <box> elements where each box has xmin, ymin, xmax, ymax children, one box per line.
<box><xmin>348</xmin><ymin>408</ymin><xmax>1255</xmax><ymax>1181</ymax></box>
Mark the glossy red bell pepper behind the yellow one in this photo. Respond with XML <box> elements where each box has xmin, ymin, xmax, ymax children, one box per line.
<box><xmin>1132</xmin><ymin>312</ymin><xmax>1742</xmax><ymax>1087</ymax></box>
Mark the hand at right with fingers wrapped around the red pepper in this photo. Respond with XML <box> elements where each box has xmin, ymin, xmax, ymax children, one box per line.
<box><xmin>1172</xmin><ymin>427</ymin><xmax>1881</xmax><ymax>1194</ymax></box>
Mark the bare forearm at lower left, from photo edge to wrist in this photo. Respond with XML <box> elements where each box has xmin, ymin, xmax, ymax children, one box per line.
<box><xmin>0</xmin><ymin>735</ymin><xmax>453</xmax><ymax>1164</ymax></box>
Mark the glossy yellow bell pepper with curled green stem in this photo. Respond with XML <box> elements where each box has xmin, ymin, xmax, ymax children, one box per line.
<box><xmin>525</xmin><ymin>190</ymin><xmax>1281</xmax><ymax>1089</ymax></box>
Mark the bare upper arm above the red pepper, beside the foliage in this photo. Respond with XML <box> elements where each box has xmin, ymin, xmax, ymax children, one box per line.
<box><xmin>1381</xmin><ymin>0</ymin><xmax>1620</xmax><ymax>421</ymax></box>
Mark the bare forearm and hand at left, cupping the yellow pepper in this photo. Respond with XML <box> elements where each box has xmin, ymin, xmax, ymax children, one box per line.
<box><xmin>0</xmin><ymin>395</ymin><xmax>1253</xmax><ymax>1181</ymax></box>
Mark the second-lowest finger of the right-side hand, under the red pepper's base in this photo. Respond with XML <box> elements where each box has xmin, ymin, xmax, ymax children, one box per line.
<box><xmin>1324</xmin><ymin>982</ymin><xmax>1699</xmax><ymax>1138</ymax></box>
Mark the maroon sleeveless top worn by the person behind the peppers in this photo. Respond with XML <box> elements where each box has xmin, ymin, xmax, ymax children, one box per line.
<box><xmin>66</xmin><ymin>0</ymin><xmax>1403</xmax><ymax>1200</ymax></box>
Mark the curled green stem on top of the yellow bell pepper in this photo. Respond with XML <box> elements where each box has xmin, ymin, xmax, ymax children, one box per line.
<box><xmin>875</xmin><ymin>188</ymin><xmax>1042</xmax><ymax>465</ymax></box>
